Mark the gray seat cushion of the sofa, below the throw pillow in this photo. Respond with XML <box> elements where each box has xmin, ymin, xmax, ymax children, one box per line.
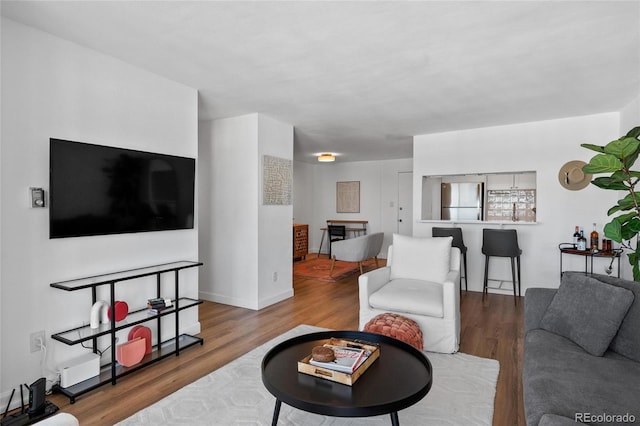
<box><xmin>522</xmin><ymin>329</ymin><xmax>640</xmax><ymax>425</ymax></box>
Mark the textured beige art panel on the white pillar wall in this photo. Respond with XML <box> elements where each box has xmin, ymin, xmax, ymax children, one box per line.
<box><xmin>262</xmin><ymin>155</ymin><xmax>293</xmax><ymax>206</ymax></box>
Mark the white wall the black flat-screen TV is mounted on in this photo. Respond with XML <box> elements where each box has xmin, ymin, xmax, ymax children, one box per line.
<box><xmin>0</xmin><ymin>18</ymin><xmax>200</xmax><ymax>407</ymax></box>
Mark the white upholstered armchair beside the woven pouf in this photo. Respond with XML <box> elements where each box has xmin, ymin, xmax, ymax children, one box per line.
<box><xmin>358</xmin><ymin>234</ymin><xmax>460</xmax><ymax>353</ymax></box>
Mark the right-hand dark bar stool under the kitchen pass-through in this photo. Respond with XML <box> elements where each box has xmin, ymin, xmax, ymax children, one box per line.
<box><xmin>482</xmin><ymin>229</ymin><xmax>522</xmax><ymax>301</ymax></box>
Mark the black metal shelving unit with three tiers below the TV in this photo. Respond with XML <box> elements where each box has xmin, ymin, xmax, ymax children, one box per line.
<box><xmin>51</xmin><ymin>261</ymin><xmax>204</xmax><ymax>404</ymax></box>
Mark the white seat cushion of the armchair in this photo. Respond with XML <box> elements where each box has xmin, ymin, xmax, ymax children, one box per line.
<box><xmin>369</xmin><ymin>278</ymin><xmax>444</xmax><ymax>318</ymax></box>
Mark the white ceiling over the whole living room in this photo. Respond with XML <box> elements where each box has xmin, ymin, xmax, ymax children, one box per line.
<box><xmin>1</xmin><ymin>1</ymin><xmax>640</xmax><ymax>161</ymax></box>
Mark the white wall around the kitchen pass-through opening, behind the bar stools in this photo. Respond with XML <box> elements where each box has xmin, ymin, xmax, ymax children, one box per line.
<box><xmin>414</xmin><ymin>113</ymin><xmax>631</xmax><ymax>294</ymax></box>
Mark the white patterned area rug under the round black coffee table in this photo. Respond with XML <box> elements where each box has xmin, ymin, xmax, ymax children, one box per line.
<box><xmin>118</xmin><ymin>325</ymin><xmax>500</xmax><ymax>426</ymax></box>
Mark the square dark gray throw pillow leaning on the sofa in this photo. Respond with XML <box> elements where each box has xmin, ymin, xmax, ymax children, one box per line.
<box><xmin>540</xmin><ymin>274</ymin><xmax>634</xmax><ymax>356</ymax></box>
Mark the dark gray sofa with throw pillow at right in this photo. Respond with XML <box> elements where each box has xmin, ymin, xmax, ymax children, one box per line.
<box><xmin>522</xmin><ymin>272</ymin><xmax>640</xmax><ymax>426</ymax></box>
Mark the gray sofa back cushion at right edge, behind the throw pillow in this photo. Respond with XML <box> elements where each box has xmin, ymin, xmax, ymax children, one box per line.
<box><xmin>578</xmin><ymin>275</ymin><xmax>640</xmax><ymax>362</ymax></box>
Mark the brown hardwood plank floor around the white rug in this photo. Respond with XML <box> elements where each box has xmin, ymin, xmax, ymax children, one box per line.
<box><xmin>48</xmin><ymin>268</ymin><xmax>525</xmax><ymax>426</ymax></box>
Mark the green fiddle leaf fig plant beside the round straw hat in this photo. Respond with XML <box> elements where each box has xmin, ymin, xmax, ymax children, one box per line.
<box><xmin>580</xmin><ymin>127</ymin><xmax>640</xmax><ymax>281</ymax></box>
